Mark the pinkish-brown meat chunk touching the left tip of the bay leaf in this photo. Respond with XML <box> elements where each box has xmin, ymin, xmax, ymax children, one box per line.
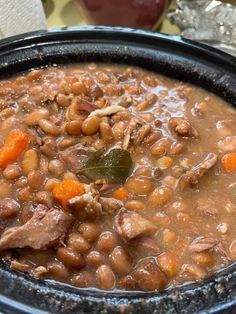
<box><xmin>59</xmin><ymin>144</ymin><xmax>96</xmax><ymax>172</ymax></box>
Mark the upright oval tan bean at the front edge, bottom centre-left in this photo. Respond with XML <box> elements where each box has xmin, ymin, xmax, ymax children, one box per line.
<box><xmin>96</xmin><ymin>265</ymin><xmax>116</xmax><ymax>290</ymax></box>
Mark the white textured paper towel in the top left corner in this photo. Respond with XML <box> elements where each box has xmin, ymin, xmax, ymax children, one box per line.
<box><xmin>0</xmin><ymin>0</ymin><xmax>47</xmax><ymax>38</ymax></box>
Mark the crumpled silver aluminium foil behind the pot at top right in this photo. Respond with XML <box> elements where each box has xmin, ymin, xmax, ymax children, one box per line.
<box><xmin>168</xmin><ymin>0</ymin><xmax>236</xmax><ymax>56</ymax></box>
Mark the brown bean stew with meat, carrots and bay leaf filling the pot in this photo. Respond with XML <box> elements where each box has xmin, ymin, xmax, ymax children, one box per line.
<box><xmin>0</xmin><ymin>64</ymin><xmax>236</xmax><ymax>291</ymax></box>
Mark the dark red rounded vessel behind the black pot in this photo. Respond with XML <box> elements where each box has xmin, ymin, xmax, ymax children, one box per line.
<box><xmin>75</xmin><ymin>0</ymin><xmax>170</xmax><ymax>29</ymax></box>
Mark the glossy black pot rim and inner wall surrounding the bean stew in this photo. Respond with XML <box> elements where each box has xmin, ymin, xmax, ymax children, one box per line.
<box><xmin>0</xmin><ymin>27</ymin><xmax>236</xmax><ymax>314</ymax></box>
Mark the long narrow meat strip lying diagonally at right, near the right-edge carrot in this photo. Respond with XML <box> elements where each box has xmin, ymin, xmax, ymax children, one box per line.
<box><xmin>179</xmin><ymin>153</ymin><xmax>217</xmax><ymax>190</ymax></box>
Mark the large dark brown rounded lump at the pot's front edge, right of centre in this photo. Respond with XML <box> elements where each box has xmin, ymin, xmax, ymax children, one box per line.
<box><xmin>131</xmin><ymin>257</ymin><xmax>167</xmax><ymax>291</ymax></box>
